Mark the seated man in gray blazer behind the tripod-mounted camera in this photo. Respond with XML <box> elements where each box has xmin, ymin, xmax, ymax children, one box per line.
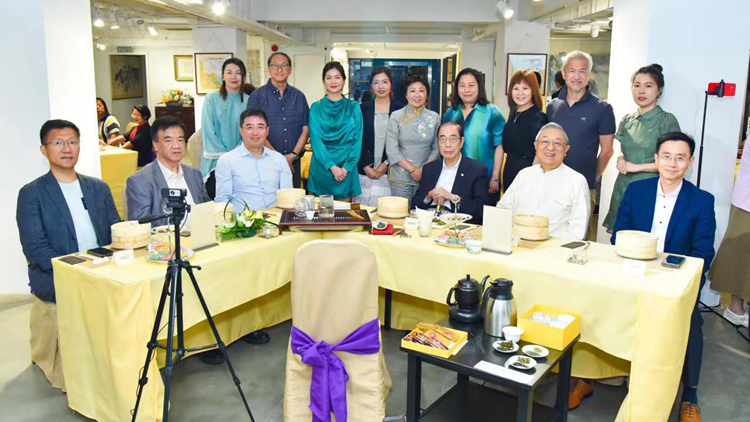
<box><xmin>126</xmin><ymin>116</ymin><xmax>211</xmax><ymax>226</ymax></box>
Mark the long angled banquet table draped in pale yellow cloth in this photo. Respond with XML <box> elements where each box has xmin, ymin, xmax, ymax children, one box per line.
<box><xmin>53</xmin><ymin>218</ymin><xmax>703</xmax><ymax>422</ymax></box>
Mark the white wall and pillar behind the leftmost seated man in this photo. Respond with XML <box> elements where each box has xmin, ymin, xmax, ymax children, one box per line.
<box><xmin>0</xmin><ymin>0</ymin><xmax>99</xmax><ymax>293</ymax></box>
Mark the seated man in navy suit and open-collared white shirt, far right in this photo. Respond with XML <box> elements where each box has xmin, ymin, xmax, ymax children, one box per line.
<box><xmin>571</xmin><ymin>132</ymin><xmax>716</xmax><ymax>422</ymax></box>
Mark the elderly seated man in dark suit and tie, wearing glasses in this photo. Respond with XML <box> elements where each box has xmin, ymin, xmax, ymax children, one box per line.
<box><xmin>412</xmin><ymin>122</ymin><xmax>490</xmax><ymax>224</ymax></box>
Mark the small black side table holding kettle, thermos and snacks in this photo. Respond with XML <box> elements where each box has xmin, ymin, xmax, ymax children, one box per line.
<box><xmin>401</xmin><ymin>318</ymin><xmax>580</xmax><ymax>422</ymax></box>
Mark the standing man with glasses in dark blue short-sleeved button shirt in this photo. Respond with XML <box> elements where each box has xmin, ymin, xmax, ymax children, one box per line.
<box><xmin>247</xmin><ymin>51</ymin><xmax>310</xmax><ymax>188</ymax></box>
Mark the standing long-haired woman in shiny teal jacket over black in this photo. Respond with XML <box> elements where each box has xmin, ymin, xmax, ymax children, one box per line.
<box><xmin>443</xmin><ymin>68</ymin><xmax>505</xmax><ymax>202</ymax></box>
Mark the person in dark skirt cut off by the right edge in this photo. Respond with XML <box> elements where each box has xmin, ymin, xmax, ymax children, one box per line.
<box><xmin>708</xmin><ymin>138</ymin><xmax>750</xmax><ymax>327</ymax></box>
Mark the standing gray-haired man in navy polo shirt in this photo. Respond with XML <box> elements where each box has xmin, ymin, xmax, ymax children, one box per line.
<box><xmin>547</xmin><ymin>51</ymin><xmax>617</xmax><ymax>240</ymax></box>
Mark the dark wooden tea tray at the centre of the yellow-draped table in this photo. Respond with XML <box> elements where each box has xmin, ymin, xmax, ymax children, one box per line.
<box><xmin>279</xmin><ymin>210</ymin><xmax>372</xmax><ymax>232</ymax></box>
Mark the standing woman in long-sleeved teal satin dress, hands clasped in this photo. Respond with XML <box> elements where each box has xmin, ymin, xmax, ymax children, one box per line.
<box><xmin>307</xmin><ymin>62</ymin><xmax>362</xmax><ymax>201</ymax></box>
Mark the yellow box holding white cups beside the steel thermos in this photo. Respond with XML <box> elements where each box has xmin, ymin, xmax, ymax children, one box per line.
<box><xmin>518</xmin><ymin>305</ymin><xmax>581</xmax><ymax>350</ymax></box>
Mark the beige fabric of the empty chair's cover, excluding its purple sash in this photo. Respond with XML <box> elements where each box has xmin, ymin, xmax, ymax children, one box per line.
<box><xmin>284</xmin><ymin>240</ymin><xmax>392</xmax><ymax>422</ymax></box>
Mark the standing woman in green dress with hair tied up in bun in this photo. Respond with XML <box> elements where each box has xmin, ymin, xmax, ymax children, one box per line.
<box><xmin>604</xmin><ymin>64</ymin><xmax>680</xmax><ymax>233</ymax></box>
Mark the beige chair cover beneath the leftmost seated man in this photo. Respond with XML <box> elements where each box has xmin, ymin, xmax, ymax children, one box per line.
<box><xmin>30</xmin><ymin>295</ymin><xmax>65</xmax><ymax>391</ymax></box>
